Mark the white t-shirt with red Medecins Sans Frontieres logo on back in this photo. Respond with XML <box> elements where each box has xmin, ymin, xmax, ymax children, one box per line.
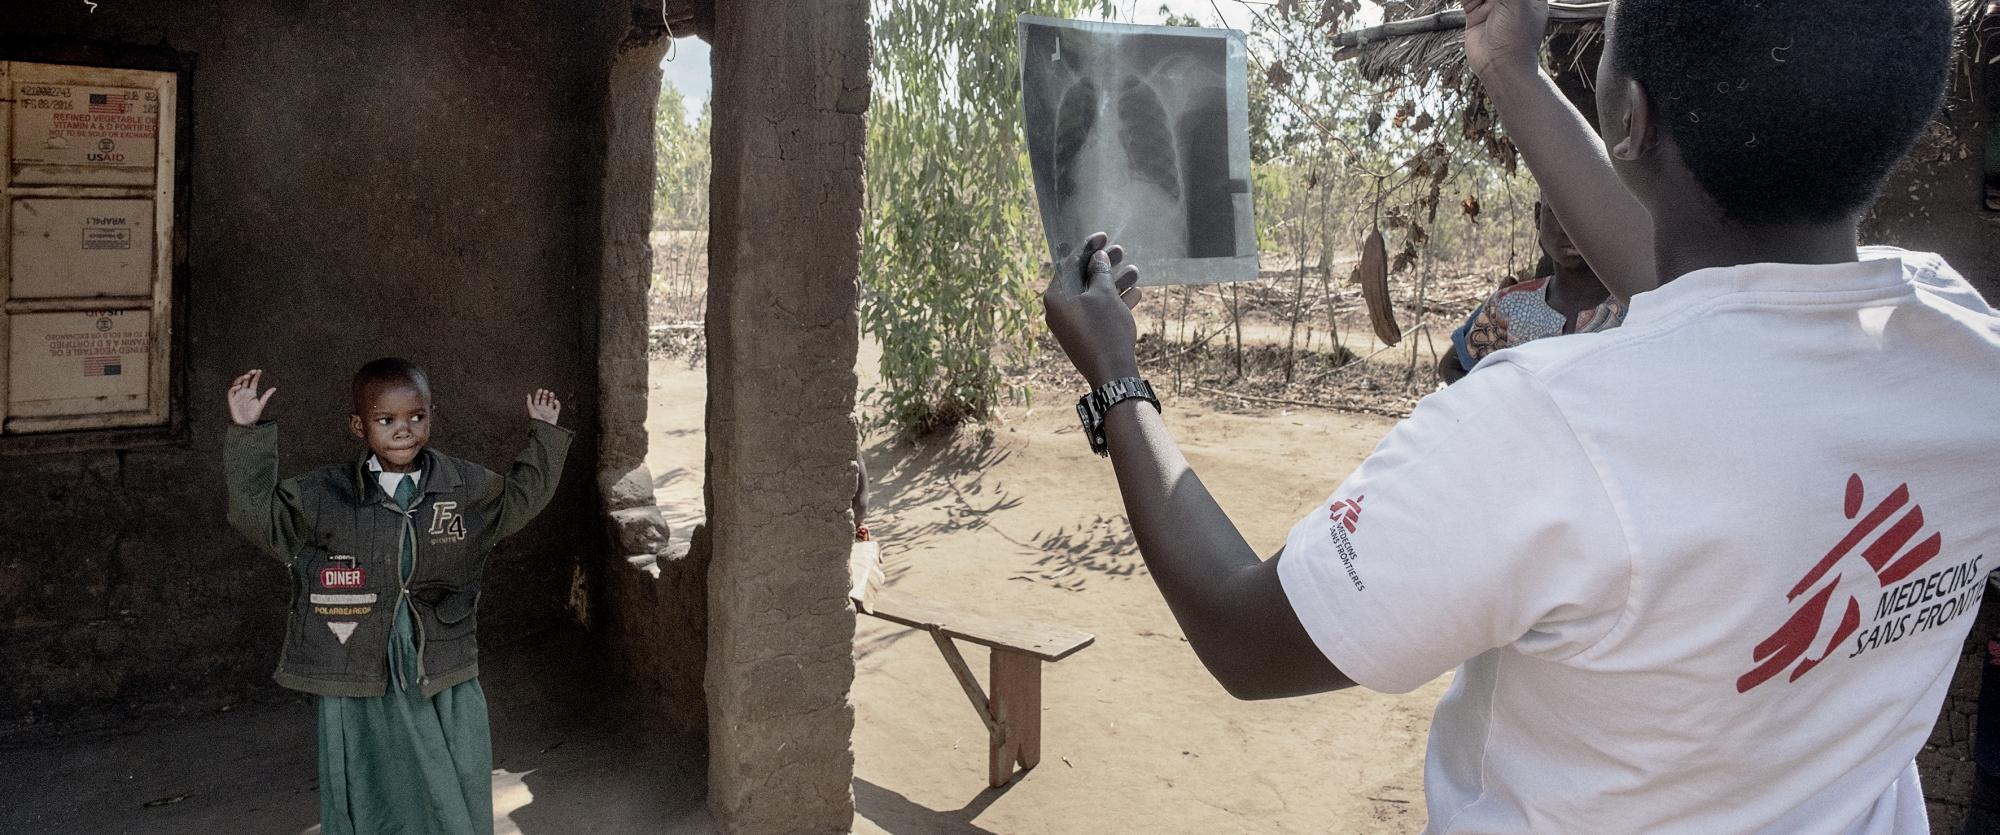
<box><xmin>1278</xmin><ymin>250</ymin><xmax>2000</xmax><ymax>835</ymax></box>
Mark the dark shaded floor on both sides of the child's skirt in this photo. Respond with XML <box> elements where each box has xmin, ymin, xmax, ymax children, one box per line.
<box><xmin>0</xmin><ymin>633</ymin><xmax>714</xmax><ymax>835</ymax></box>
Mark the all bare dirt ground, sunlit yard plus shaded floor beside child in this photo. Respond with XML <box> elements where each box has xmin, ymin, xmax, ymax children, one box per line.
<box><xmin>0</xmin><ymin>341</ymin><xmax>1444</xmax><ymax>835</ymax></box>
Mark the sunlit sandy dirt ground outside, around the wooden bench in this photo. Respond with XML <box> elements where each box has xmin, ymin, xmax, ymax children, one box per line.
<box><xmin>648</xmin><ymin>341</ymin><xmax>1444</xmax><ymax>835</ymax></box>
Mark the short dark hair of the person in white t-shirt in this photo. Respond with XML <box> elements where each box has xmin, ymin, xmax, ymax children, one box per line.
<box><xmin>1610</xmin><ymin>0</ymin><xmax>1952</xmax><ymax>226</ymax></box>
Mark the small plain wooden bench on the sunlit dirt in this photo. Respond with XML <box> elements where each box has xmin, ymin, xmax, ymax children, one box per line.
<box><xmin>852</xmin><ymin>543</ymin><xmax>1096</xmax><ymax>787</ymax></box>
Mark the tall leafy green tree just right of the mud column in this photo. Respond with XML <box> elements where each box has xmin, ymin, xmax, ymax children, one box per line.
<box><xmin>862</xmin><ymin>0</ymin><xmax>1110</xmax><ymax>433</ymax></box>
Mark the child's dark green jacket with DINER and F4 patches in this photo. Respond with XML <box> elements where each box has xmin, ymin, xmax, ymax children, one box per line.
<box><xmin>224</xmin><ymin>419</ymin><xmax>572</xmax><ymax>695</ymax></box>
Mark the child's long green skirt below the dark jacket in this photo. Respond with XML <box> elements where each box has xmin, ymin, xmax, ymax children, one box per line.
<box><xmin>320</xmin><ymin>595</ymin><xmax>494</xmax><ymax>835</ymax></box>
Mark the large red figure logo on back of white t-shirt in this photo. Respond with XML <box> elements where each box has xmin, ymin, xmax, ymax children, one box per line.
<box><xmin>1736</xmin><ymin>475</ymin><xmax>1944</xmax><ymax>693</ymax></box>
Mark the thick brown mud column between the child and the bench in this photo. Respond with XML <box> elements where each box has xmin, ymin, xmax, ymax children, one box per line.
<box><xmin>706</xmin><ymin>0</ymin><xmax>868</xmax><ymax>833</ymax></box>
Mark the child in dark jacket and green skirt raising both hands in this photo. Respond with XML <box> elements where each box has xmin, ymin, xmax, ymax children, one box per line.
<box><xmin>224</xmin><ymin>358</ymin><xmax>570</xmax><ymax>835</ymax></box>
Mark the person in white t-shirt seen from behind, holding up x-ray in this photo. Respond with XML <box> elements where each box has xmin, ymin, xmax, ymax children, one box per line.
<box><xmin>1044</xmin><ymin>0</ymin><xmax>2000</xmax><ymax>833</ymax></box>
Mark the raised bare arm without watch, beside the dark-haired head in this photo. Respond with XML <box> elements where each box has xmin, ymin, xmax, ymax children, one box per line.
<box><xmin>1466</xmin><ymin>0</ymin><xmax>1660</xmax><ymax>302</ymax></box>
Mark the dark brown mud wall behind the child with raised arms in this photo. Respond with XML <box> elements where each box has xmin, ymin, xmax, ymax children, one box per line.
<box><xmin>0</xmin><ymin>0</ymin><xmax>624</xmax><ymax>743</ymax></box>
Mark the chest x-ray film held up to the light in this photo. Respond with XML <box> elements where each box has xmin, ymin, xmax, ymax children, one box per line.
<box><xmin>1020</xmin><ymin>16</ymin><xmax>1258</xmax><ymax>284</ymax></box>
